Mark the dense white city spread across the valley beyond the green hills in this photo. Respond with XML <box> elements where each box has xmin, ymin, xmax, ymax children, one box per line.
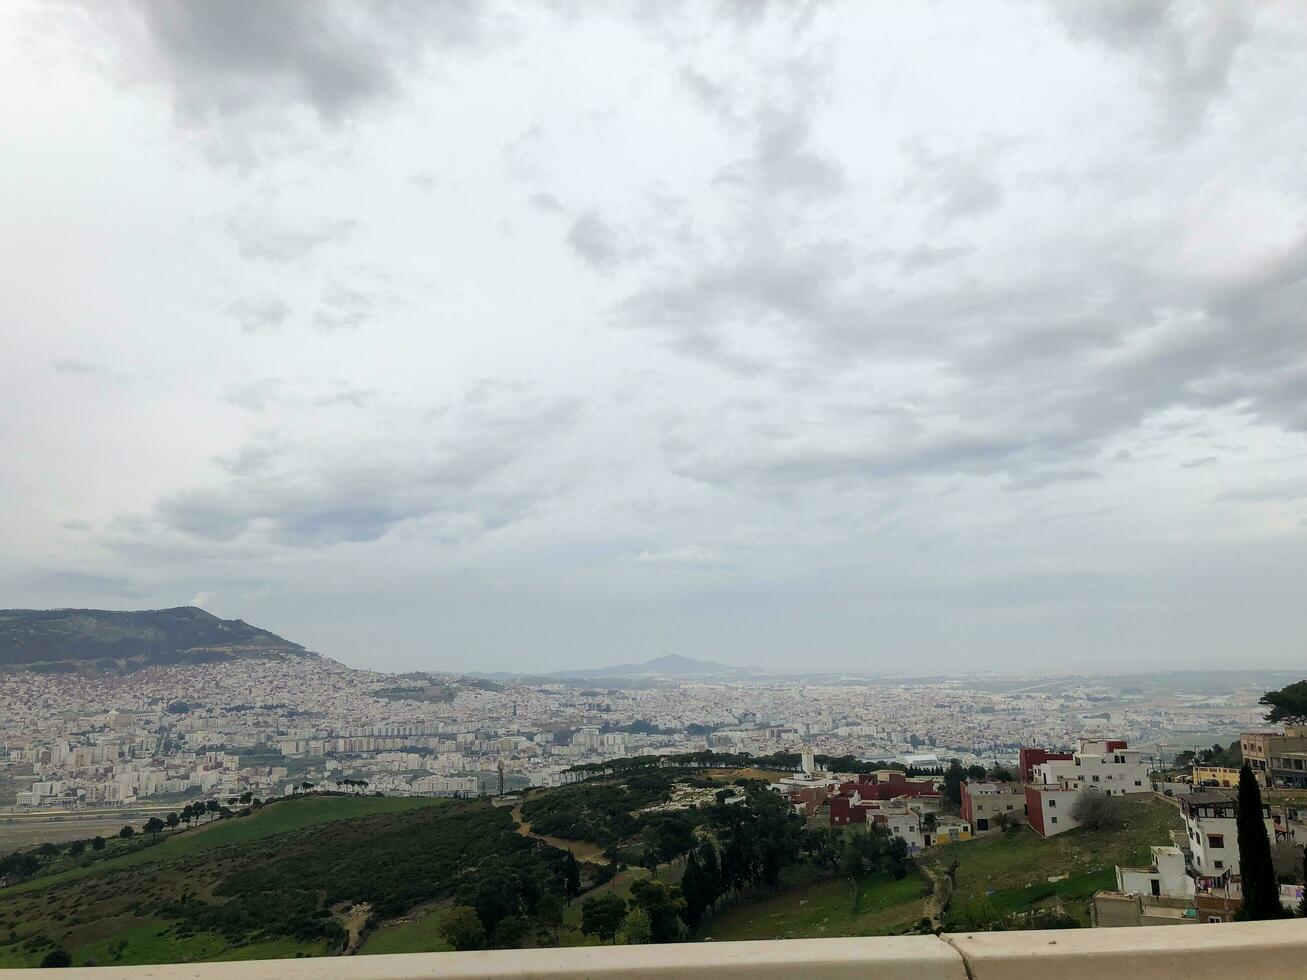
<box><xmin>0</xmin><ymin>656</ymin><xmax>1261</xmax><ymax>810</ymax></box>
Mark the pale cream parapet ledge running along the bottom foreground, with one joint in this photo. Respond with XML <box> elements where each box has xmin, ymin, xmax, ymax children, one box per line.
<box><xmin>0</xmin><ymin>920</ymin><xmax>1307</xmax><ymax>980</ymax></box>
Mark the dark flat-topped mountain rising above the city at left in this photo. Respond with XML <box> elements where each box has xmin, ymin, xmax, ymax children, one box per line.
<box><xmin>0</xmin><ymin>606</ymin><xmax>316</xmax><ymax>672</ymax></box>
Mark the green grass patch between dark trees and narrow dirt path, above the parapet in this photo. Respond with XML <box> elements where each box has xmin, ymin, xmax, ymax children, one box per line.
<box><xmin>699</xmin><ymin>874</ymin><xmax>925</xmax><ymax>942</ymax></box>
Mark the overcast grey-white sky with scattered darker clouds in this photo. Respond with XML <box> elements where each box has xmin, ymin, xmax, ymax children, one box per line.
<box><xmin>0</xmin><ymin>0</ymin><xmax>1307</xmax><ymax>672</ymax></box>
